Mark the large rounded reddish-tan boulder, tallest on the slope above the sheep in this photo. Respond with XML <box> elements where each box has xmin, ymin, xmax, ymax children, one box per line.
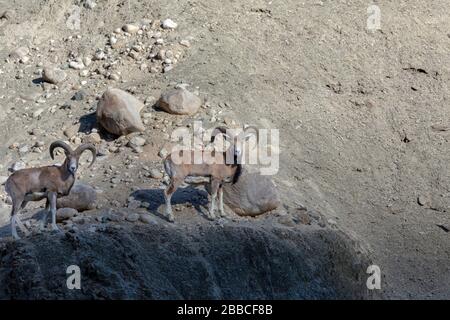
<box><xmin>97</xmin><ymin>88</ymin><xmax>145</xmax><ymax>136</ymax></box>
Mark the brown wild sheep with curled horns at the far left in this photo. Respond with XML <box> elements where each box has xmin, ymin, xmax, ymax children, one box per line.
<box><xmin>5</xmin><ymin>141</ymin><xmax>96</xmax><ymax>239</ymax></box>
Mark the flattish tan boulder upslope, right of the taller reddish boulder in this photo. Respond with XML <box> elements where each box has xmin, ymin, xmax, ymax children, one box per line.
<box><xmin>158</xmin><ymin>88</ymin><xmax>202</xmax><ymax>115</ymax></box>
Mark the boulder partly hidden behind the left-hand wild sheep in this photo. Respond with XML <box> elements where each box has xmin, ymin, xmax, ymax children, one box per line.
<box><xmin>56</xmin><ymin>183</ymin><xmax>97</xmax><ymax>211</ymax></box>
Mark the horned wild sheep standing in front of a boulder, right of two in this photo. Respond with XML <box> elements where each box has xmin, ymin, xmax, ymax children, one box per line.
<box><xmin>163</xmin><ymin>127</ymin><xmax>259</xmax><ymax>222</ymax></box>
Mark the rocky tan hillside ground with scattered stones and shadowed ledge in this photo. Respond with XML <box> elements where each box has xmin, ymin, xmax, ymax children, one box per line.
<box><xmin>0</xmin><ymin>0</ymin><xmax>450</xmax><ymax>298</ymax></box>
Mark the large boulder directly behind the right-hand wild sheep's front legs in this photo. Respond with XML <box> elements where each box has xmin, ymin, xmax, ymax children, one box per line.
<box><xmin>223</xmin><ymin>169</ymin><xmax>280</xmax><ymax>216</ymax></box>
